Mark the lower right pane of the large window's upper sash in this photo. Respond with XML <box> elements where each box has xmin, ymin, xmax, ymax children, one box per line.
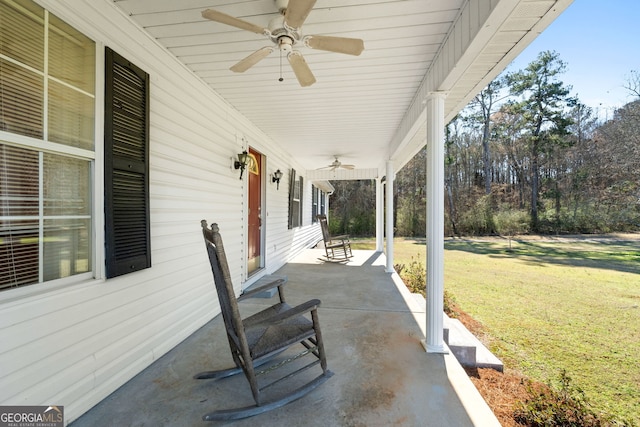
<box><xmin>49</xmin><ymin>81</ymin><xmax>94</xmax><ymax>150</ymax></box>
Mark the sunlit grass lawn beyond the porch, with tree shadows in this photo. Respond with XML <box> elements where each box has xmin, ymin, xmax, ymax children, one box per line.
<box><xmin>352</xmin><ymin>235</ymin><xmax>640</xmax><ymax>425</ymax></box>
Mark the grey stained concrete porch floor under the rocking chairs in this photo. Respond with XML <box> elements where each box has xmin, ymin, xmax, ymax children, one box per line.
<box><xmin>71</xmin><ymin>249</ymin><xmax>500</xmax><ymax>427</ymax></box>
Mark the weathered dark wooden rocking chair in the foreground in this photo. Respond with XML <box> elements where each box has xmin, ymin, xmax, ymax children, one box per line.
<box><xmin>194</xmin><ymin>220</ymin><xmax>333</xmax><ymax>421</ymax></box>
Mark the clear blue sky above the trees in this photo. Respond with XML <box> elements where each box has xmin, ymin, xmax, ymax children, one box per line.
<box><xmin>507</xmin><ymin>0</ymin><xmax>640</xmax><ymax>118</ymax></box>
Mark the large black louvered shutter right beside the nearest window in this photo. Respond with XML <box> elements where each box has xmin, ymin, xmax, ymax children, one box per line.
<box><xmin>104</xmin><ymin>48</ymin><xmax>151</xmax><ymax>278</ymax></box>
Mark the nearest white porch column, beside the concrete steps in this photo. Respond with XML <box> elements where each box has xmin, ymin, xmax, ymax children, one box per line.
<box><xmin>425</xmin><ymin>92</ymin><xmax>447</xmax><ymax>353</ymax></box>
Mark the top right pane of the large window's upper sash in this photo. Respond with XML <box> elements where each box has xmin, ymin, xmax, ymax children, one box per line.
<box><xmin>49</xmin><ymin>14</ymin><xmax>96</xmax><ymax>94</ymax></box>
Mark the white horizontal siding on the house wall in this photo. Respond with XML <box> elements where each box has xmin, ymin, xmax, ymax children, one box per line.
<box><xmin>0</xmin><ymin>0</ymin><xmax>320</xmax><ymax>422</ymax></box>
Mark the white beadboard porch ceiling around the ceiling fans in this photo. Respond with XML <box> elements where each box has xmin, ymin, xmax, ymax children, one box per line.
<box><xmin>113</xmin><ymin>0</ymin><xmax>571</xmax><ymax>174</ymax></box>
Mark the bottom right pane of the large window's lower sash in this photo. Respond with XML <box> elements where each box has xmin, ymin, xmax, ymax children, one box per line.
<box><xmin>43</xmin><ymin>219</ymin><xmax>91</xmax><ymax>281</ymax></box>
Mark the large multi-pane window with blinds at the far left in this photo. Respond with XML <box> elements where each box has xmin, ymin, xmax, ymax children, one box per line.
<box><xmin>0</xmin><ymin>0</ymin><xmax>95</xmax><ymax>290</ymax></box>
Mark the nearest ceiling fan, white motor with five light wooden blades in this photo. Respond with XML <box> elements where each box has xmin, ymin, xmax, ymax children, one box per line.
<box><xmin>202</xmin><ymin>0</ymin><xmax>364</xmax><ymax>87</ymax></box>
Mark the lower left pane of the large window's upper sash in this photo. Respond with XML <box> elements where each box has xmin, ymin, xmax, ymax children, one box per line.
<box><xmin>0</xmin><ymin>59</ymin><xmax>44</xmax><ymax>139</ymax></box>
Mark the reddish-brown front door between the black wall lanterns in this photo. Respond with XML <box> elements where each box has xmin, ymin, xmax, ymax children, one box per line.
<box><xmin>247</xmin><ymin>148</ymin><xmax>262</xmax><ymax>274</ymax></box>
